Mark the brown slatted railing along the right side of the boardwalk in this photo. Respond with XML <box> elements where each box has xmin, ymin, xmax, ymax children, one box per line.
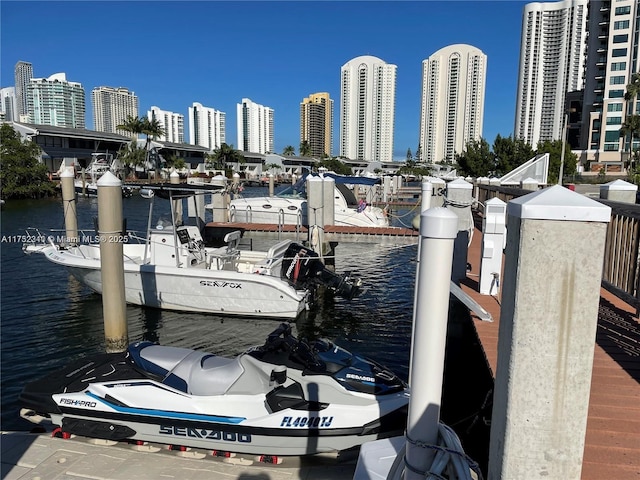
<box><xmin>476</xmin><ymin>185</ymin><xmax>640</xmax><ymax>315</ymax></box>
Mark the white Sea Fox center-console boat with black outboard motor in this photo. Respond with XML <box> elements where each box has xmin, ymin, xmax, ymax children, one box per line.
<box><xmin>23</xmin><ymin>184</ymin><xmax>360</xmax><ymax>319</ymax></box>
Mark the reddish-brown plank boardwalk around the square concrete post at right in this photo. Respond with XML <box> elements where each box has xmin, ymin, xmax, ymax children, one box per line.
<box><xmin>461</xmin><ymin>219</ymin><xmax>640</xmax><ymax>480</ymax></box>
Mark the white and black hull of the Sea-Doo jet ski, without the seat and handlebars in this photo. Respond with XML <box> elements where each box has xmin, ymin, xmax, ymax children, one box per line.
<box><xmin>21</xmin><ymin>326</ymin><xmax>409</xmax><ymax>456</ymax></box>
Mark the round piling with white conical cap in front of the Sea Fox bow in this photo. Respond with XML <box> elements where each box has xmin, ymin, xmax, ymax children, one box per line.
<box><xmin>98</xmin><ymin>172</ymin><xmax>129</xmax><ymax>353</ymax></box>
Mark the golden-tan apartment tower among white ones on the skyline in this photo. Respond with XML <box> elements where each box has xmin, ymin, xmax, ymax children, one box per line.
<box><xmin>300</xmin><ymin>92</ymin><xmax>333</xmax><ymax>157</ymax></box>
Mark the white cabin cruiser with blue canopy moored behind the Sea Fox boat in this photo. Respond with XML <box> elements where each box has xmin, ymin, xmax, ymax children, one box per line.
<box><xmin>207</xmin><ymin>173</ymin><xmax>389</xmax><ymax>227</ymax></box>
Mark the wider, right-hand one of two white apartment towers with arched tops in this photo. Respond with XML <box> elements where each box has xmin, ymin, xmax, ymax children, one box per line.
<box><xmin>418</xmin><ymin>44</ymin><xmax>487</xmax><ymax>163</ymax></box>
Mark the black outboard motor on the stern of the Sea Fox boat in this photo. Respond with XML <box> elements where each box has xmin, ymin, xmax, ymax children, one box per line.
<box><xmin>282</xmin><ymin>243</ymin><xmax>362</xmax><ymax>300</ymax></box>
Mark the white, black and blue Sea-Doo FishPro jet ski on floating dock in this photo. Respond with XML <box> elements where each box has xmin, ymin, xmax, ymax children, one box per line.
<box><xmin>20</xmin><ymin>323</ymin><xmax>409</xmax><ymax>456</ymax></box>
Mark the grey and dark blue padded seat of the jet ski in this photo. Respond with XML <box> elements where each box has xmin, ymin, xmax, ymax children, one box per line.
<box><xmin>129</xmin><ymin>342</ymin><xmax>244</xmax><ymax>395</ymax></box>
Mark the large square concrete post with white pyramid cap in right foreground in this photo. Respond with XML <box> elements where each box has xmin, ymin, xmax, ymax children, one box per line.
<box><xmin>488</xmin><ymin>185</ymin><xmax>611</xmax><ymax>480</ymax></box>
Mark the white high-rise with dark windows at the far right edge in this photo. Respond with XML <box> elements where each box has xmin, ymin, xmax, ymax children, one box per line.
<box><xmin>580</xmin><ymin>0</ymin><xmax>640</xmax><ymax>172</ymax></box>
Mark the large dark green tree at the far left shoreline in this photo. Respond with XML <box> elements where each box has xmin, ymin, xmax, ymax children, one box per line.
<box><xmin>0</xmin><ymin>123</ymin><xmax>56</xmax><ymax>199</ymax></box>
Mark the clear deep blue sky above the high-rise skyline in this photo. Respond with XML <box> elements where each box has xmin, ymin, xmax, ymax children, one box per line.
<box><xmin>0</xmin><ymin>0</ymin><xmax>530</xmax><ymax>160</ymax></box>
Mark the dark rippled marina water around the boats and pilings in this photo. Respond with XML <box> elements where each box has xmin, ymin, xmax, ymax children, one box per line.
<box><xmin>0</xmin><ymin>188</ymin><xmax>416</xmax><ymax>430</ymax></box>
